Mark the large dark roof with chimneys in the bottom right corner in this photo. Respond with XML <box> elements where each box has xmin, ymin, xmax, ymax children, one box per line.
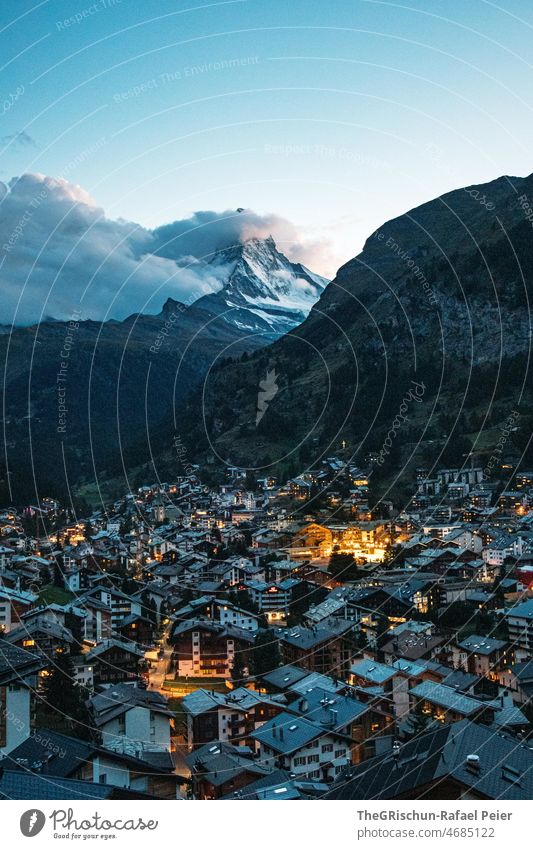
<box><xmin>321</xmin><ymin>719</ymin><xmax>533</xmax><ymax>804</ymax></box>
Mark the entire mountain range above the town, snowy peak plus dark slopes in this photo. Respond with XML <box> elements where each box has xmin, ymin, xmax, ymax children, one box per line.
<box><xmin>4</xmin><ymin>170</ymin><xmax>533</xmax><ymax>502</ymax></box>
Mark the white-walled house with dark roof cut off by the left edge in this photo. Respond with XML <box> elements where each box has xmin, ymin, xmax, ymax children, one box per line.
<box><xmin>0</xmin><ymin>640</ymin><xmax>46</xmax><ymax>755</ymax></box>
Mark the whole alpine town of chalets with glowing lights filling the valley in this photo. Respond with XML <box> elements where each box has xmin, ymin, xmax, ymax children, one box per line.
<box><xmin>0</xmin><ymin>457</ymin><xmax>533</xmax><ymax>800</ymax></box>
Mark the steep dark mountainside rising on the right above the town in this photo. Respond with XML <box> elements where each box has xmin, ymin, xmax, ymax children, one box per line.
<box><xmin>179</xmin><ymin>176</ymin><xmax>533</xmax><ymax>496</ymax></box>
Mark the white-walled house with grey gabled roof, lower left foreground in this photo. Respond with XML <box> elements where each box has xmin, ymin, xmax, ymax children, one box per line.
<box><xmin>87</xmin><ymin>684</ymin><xmax>174</xmax><ymax>756</ymax></box>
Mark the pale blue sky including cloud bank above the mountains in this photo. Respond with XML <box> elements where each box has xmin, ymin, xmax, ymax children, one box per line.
<box><xmin>0</xmin><ymin>0</ymin><xmax>533</xmax><ymax>322</ymax></box>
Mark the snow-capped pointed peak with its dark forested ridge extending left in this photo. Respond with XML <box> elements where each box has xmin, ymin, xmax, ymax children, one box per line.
<box><xmin>0</xmin><ymin>238</ymin><xmax>327</xmax><ymax>504</ymax></box>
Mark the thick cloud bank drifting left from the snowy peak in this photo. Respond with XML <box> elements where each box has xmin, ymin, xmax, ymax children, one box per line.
<box><xmin>0</xmin><ymin>174</ymin><xmax>332</xmax><ymax>324</ymax></box>
